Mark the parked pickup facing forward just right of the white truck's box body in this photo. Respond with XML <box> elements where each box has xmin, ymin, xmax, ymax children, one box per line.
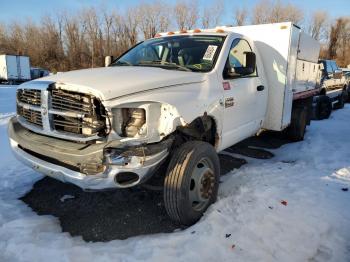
<box><xmin>315</xmin><ymin>59</ymin><xmax>348</xmax><ymax>119</ymax></box>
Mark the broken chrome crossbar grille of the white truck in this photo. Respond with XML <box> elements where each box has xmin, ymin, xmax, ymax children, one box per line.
<box><xmin>17</xmin><ymin>86</ymin><xmax>107</xmax><ymax>141</ymax></box>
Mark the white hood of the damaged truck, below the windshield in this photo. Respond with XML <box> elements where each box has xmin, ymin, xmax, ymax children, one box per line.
<box><xmin>38</xmin><ymin>66</ymin><xmax>205</xmax><ymax>100</ymax></box>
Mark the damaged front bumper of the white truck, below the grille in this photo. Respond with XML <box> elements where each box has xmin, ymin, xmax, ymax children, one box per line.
<box><xmin>8</xmin><ymin>117</ymin><xmax>171</xmax><ymax>190</ymax></box>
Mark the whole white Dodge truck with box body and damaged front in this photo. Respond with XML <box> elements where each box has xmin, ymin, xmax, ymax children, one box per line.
<box><xmin>9</xmin><ymin>22</ymin><xmax>320</xmax><ymax>225</ymax></box>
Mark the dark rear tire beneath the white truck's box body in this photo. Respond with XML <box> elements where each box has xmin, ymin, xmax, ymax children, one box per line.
<box><xmin>287</xmin><ymin>107</ymin><xmax>308</xmax><ymax>142</ymax></box>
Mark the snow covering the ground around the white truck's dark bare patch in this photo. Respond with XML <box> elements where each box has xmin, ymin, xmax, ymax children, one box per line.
<box><xmin>0</xmin><ymin>85</ymin><xmax>350</xmax><ymax>262</ymax></box>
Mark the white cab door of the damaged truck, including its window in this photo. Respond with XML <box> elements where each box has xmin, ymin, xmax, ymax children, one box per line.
<box><xmin>222</xmin><ymin>38</ymin><xmax>267</xmax><ymax>145</ymax></box>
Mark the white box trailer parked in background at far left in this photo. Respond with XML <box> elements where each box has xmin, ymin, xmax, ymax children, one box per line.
<box><xmin>0</xmin><ymin>55</ymin><xmax>31</xmax><ymax>84</ymax></box>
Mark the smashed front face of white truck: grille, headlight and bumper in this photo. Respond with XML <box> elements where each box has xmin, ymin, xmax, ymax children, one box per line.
<box><xmin>9</xmin><ymin>83</ymin><xmax>173</xmax><ymax>190</ymax></box>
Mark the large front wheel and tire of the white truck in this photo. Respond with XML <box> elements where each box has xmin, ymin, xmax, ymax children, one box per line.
<box><xmin>164</xmin><ymin>141</ymin><xmax>220</xmax><ymax>225</ymax></box>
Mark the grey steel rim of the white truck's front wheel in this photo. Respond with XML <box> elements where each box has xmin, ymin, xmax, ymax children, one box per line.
<box><xmin>189</xmin><ymin>158</ymin><xmax>215</xmax><ymax>211</ymax></box>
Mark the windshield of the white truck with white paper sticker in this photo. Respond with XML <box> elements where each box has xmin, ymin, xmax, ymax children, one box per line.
<box><xmin>111</xmin><ymin>35</ymin><xmax>224</xmax><ymax>72</ymax></box>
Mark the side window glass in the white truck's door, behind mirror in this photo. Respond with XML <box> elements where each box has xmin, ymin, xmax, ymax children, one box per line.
<box><xmin>227</xmin><ymin>38</ymin><xmax>257</xmax><ymax>77</ymax></box>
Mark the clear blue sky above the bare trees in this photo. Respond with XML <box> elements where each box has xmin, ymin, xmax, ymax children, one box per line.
<box><xmin>0</xmin><ymin>0</ymin><xmax>350</xmax><ymax>24</ymax></box>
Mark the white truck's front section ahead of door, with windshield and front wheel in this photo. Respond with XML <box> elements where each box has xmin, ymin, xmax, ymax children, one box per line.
<box><xmin>8</xmin><ymin>32</ymin><xmax>227</xmax><ymax>225</ymax></box>
